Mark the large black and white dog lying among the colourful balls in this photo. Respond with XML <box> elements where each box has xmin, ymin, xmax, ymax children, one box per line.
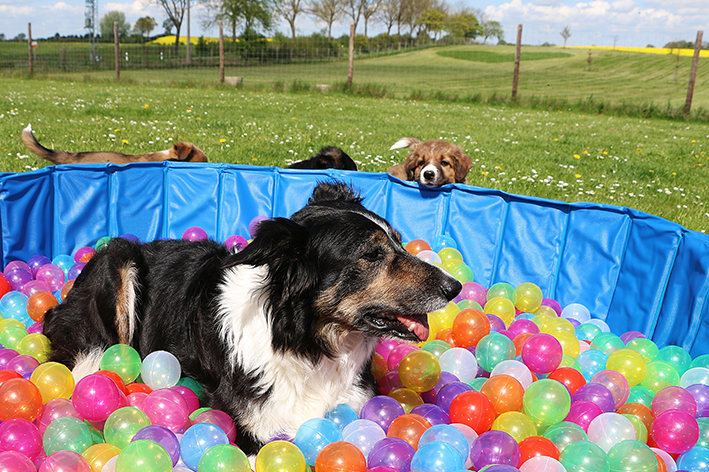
<box><xmin>44</xmin><ymin>182</ymin><xmax>461</xmax><ymax>455</ymax></box>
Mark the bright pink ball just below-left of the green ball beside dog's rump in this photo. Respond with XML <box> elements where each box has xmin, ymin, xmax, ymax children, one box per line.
<box><xmin>72</xmin><ymin>374</ymin><xmax>122</xmax><ymax>421</ymax></box>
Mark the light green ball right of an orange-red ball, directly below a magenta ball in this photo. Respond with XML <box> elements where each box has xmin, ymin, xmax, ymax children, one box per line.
<box><xmin>524</xmin><ymin>379</ymin><xmax>571</xmax><ymax>426</ymax></box>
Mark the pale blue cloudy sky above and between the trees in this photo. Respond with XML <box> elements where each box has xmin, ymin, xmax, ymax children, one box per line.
<box><xmin>0</xmin><ymin>0</ymin><xmax>709</xmax><ymax>47</ymax></box>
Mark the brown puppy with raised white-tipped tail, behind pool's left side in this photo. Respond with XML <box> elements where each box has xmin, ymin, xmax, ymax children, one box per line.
<box><xmin>21</xmin><ymin>125</ymin><xmax>207</xmax><ymax>164</ymax></box>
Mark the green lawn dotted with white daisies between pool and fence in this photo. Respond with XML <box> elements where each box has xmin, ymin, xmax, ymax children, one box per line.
<box><xmin>0</xmin><ymin>76</ymin><xmax>709</xmax><ymax>231</ymax></box>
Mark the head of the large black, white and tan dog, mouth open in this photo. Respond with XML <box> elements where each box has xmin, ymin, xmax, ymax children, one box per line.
<box><xmin>224</xmin><ymin>183</ymin><xmax>461</xmax><ymax>356</ymax></box>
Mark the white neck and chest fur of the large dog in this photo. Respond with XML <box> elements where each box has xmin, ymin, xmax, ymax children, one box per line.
<box><xmin>219</xmin><ymin>266</ymin><xmax>375</xmax><ymax>442</ymax></box>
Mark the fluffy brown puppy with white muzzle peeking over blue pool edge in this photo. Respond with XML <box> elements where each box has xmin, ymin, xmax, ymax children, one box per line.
<box><xmin>387</xmin><ymin>138</ymin><xmax>473</xmax><ymax>187</ymax></box>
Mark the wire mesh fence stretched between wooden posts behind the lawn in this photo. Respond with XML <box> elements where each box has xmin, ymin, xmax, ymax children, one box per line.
<box><xmin>0</xmin><ymin>26</ymin><xmax>709</xmax><ymax>118</ymax></box>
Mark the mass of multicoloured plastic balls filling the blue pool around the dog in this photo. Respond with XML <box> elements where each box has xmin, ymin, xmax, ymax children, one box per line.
<box><xmin>0</xmin><ymin>208</ymin><xmax>709</xmax><ymax>472</ymax></box>
